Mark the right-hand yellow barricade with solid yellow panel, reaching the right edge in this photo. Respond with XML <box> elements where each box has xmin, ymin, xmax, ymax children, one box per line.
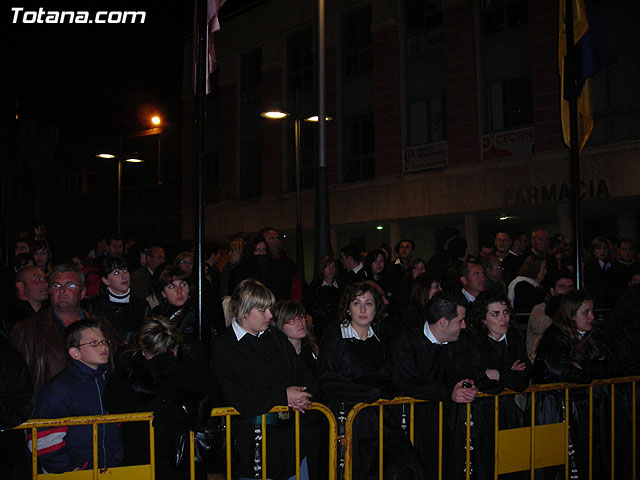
<box><xmin>339</xmin><ymin>376</ymin><xmax>640</xmax><ymax>480</ymax></box>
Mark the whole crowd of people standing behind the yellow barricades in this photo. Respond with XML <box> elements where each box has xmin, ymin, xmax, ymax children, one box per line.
<box><xmin>0</xmin><ymin>227</ymin><xmax>640</xmax><ymax>479</ymax></box>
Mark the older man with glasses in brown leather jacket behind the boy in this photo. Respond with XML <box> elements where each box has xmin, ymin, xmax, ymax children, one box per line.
<box><xmin>11</xmin><ymin>263</ymin><xmax>118</xmax><ymax>398</ymax></box>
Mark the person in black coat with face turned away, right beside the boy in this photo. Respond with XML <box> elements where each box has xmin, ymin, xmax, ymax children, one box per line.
<box><xmin>104</xmin><ymin>315</ymin><xmax>220</xmax><ymax>480</ymax></box>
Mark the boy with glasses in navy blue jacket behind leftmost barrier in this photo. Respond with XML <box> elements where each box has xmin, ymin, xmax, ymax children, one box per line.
<box><xmin>29</xmin><ymin>319</ymin><xmax>122</xmax><ymax>473</ymax></box>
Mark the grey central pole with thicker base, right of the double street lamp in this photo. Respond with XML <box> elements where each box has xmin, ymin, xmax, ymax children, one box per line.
<box><xmin>315</xmin><ymin>0</ymin><xmax>331</xmax><ymax>273</ymax></box>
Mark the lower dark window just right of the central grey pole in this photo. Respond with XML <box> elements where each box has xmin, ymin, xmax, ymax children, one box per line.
<box><xmin>343</xmin><ymin>114</ymin><xmax>375</xmax><ymax>182</ymax></box>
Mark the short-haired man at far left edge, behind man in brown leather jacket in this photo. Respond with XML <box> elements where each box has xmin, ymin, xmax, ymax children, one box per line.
<box><xmin>0</xmin><ymin>266</ymin><xmax>49</xmax><ymax>340</ymax></box>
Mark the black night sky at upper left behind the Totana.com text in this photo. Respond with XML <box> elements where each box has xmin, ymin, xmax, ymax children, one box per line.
<box><xmin>0</xmin><ymin>0</ymin><xmax>193</xmax><ymax>137</ymax></box>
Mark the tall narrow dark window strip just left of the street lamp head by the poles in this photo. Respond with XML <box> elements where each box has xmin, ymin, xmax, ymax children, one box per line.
<box><xmin>239</xmin><ymin>49</ymin><xmax>262</xmax><ymax>198</ymax></box>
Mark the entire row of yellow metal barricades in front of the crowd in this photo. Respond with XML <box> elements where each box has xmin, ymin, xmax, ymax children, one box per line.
<box><xmin>11</xmin><ymin>376</ymin><xmax>640</xmax><ymax>480</ymax></box>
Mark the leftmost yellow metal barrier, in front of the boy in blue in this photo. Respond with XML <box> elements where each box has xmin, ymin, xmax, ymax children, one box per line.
<box><xmin>15</xmin><ymin>412</ymin><xmax>155</xmax><ymax>480</ymax></box>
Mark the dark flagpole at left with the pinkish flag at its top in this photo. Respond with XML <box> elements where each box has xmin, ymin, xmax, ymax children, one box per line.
<box><xmin>194</xmin><ymin>0</ymin><xmax>208</xmax><ymax>351</ymax></box>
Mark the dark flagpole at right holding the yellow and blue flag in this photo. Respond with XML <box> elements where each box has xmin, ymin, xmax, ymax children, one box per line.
<box><xmin>561</xmin><ymin>0</ymin><xmax>583</xmax><ymax>289</ymax></box>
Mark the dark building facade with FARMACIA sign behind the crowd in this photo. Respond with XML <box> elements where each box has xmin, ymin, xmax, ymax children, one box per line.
<box><xmin>182</xmin><ymin>0</ymin><xmax>640</xmax><ymax>271</ymax></box>
